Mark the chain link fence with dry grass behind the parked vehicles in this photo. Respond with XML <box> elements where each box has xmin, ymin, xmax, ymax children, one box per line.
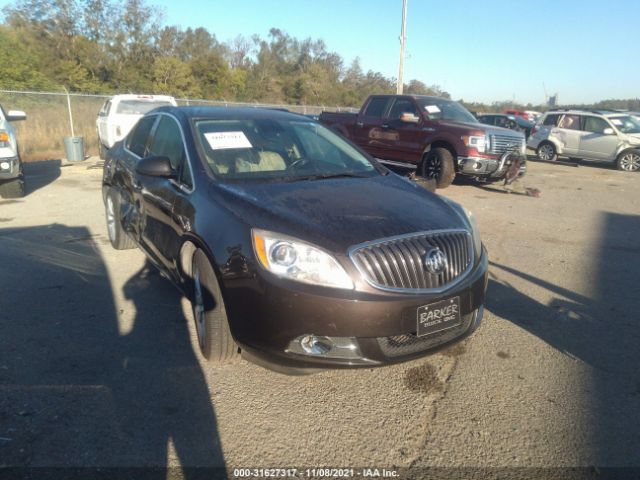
<box><xmin>0</xmin><ymin>90</ymin><xmax>358</xmax><ymax>161</ymax></box>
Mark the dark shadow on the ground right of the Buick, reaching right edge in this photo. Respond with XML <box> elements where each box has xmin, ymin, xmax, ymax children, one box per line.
<box><xmin>487</xmin><ymin>213</ymin><xmax>640</xmax><ymax>466</ymax></box>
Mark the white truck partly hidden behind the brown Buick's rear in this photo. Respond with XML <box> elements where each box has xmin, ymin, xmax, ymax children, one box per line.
<box><xmin>96</xmin><ymin>94</ymin><xmax>177</xmax><ymax>159</ymax></box>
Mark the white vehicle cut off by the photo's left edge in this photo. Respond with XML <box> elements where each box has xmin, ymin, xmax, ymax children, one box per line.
<box><xmin>0</xmin><ymin>105</ymin><xmax>27</xmax><ymax>198</ymax></box>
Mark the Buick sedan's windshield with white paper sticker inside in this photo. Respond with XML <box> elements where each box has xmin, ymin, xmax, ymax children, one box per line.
<box><xmin>195</xmin><ymin>119</ymin><xmax>377</xmax><ymax>181</ymax></box>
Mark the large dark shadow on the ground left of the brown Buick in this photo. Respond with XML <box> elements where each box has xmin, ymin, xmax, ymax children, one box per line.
<box><xmin>0</xmin><ymin>224</ymin><xmax>226</xmax><ymax>479</ymax></box>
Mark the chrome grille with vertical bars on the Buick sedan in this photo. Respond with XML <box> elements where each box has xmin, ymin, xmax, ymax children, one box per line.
<box><xmin>349</xmin><ymin>230</ymin><xmax>473</xmax><ymax>293</ymax></box>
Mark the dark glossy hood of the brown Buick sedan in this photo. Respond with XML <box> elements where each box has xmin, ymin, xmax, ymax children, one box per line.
<box><xmin>213</xmin><ymin>173</ymin><xmax>468</xmax><ymax>252</ymax></box>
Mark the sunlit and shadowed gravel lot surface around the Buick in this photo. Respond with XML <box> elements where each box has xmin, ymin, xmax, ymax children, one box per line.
<box><xmin>0</xmin><ymin>159</ymin><xmax>640</xmax><ymax>478</ymax></box>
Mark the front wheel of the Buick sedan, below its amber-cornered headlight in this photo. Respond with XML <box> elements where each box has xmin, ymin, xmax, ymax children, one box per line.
<box><xmin>191</xmin><ymin>249</ymin><xmax>238</xmax><ymax>364</ymax></box>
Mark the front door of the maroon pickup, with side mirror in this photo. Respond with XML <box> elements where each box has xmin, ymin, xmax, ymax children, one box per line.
<box><xmin>377</xmin><ymin>97</ymin><xmax>424</xmax><ymax>164</ymax></box>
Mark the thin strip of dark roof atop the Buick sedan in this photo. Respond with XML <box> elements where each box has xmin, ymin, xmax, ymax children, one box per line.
<box><xmin>153</xmin><ymin>106</ymin><xmax>313</xmax><ymax>122</ymax></box>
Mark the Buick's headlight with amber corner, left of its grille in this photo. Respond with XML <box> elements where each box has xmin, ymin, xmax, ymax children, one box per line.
<box><xmin>251</xmin><ymin>230</ymin><xmax>353</xmax><ymax>289</ymax></box>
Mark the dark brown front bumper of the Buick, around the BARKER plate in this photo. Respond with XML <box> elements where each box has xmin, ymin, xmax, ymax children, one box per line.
<box><xmin>225</xmin><ymin>249</ymin><xmax>488</xmax><ymax>369</ymax></box>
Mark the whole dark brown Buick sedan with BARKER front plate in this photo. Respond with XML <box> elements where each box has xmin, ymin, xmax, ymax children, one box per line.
<box><xmin>103</xmin><ymin>107</ymin><xmax>487</xmax><ymax>371</ymax></box>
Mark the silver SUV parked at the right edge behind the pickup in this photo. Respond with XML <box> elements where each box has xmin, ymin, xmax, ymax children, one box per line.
<box><xmin>527</xmin><ymin>110</ymin><xmax>640</xmax><ymax>172</ymax></box>
